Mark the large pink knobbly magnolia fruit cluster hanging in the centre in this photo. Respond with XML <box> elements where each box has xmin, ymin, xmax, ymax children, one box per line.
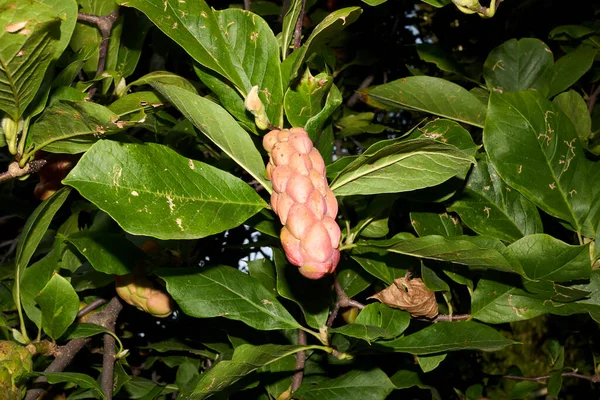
<box><xmin>263</xmin><ymin>128</ymin><xmax>341</xmax><ymax>279</ymax></box>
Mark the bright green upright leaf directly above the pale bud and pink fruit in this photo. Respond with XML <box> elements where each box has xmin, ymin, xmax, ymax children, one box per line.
<box><xmin>213</xmin><ymin>8</ymin><xmax>283</xmax><ymax>126</ymax></box>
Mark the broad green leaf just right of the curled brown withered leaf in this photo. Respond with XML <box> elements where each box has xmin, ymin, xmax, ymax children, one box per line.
<box><xmin>471</xmin><ymin>275</ymin><xmax>551</xmax><ymax>324</ymax></box>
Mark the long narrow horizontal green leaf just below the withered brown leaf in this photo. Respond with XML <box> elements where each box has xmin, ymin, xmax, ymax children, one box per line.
<box><xmin>379</xmin><ymin>321</ymin><xmax>515</xmax><ymax>355</ymax></box>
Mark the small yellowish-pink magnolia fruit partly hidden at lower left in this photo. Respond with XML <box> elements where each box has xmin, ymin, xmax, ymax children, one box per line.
<box><xmin>115</xmin><ymin>274</ymin><xmax>173</xmax><ymax>318</ymax></box>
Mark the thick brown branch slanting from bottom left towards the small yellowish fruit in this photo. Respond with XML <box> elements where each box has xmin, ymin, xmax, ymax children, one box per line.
<box><xmin>25</xmin><ymin>297</ymin><xmax>123</xmax><ymax>400</ymax></box>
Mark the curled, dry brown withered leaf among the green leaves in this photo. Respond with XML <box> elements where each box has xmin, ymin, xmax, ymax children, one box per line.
<box><xmin>369</xmin><ymin>277</ymin><xmax>438</xmax><ymax>318</ymax></box>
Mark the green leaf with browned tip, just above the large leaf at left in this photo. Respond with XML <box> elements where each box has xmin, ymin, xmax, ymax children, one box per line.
<box><xmin>26</xmin><ymin>101</ymin><xmax>122</xmax><ymax>154</ymax></box>
